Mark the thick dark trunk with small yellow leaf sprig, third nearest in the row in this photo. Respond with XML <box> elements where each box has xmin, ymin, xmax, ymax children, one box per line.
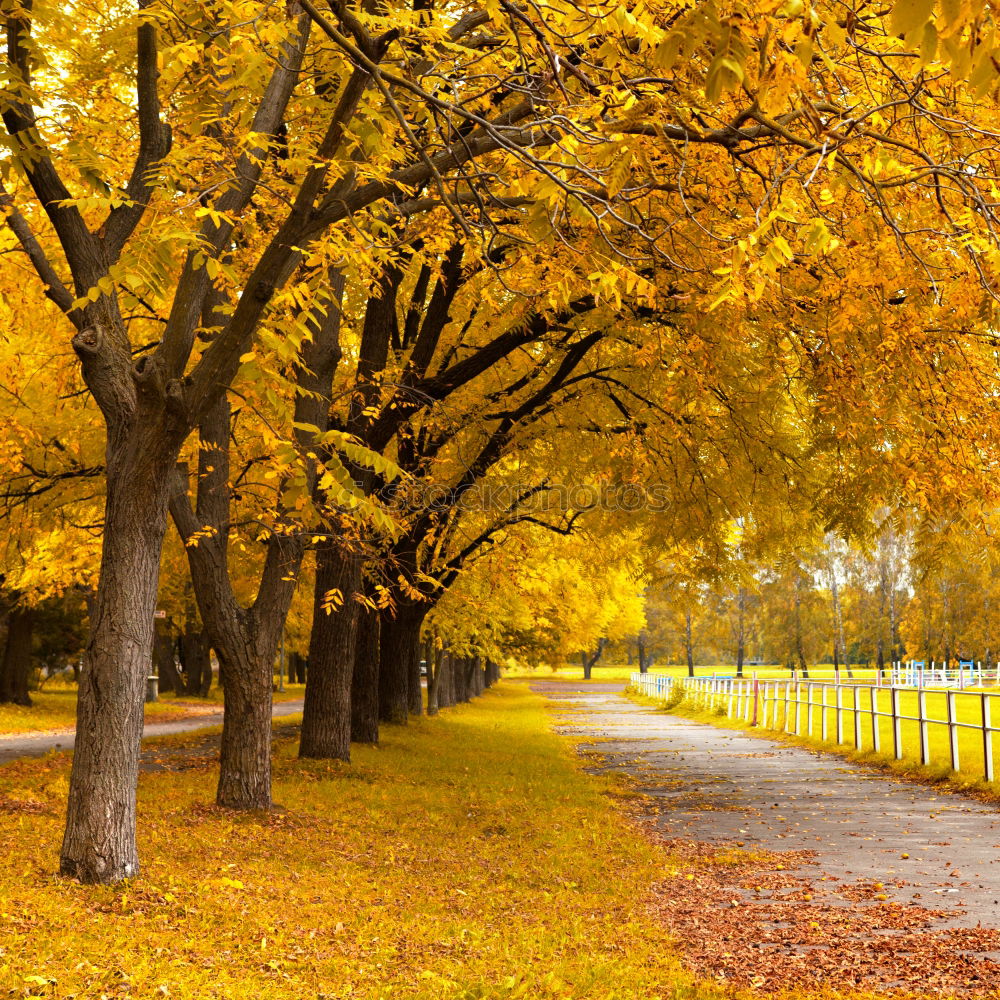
<box><xmin>299</xmin><ymin>548</ymin><xmax>361</xmax><ymax>760</ymax></box>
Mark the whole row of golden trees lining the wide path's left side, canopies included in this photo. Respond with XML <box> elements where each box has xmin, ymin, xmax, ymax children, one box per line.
<box><xmin>0</xmin><ymin>0</ymin><xmax>1000</xmax><ymax>882</ymax></box>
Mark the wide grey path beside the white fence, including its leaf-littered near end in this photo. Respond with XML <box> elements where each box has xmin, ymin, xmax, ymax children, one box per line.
<box><xmin>532</xmin><ymin>681</ymin><xmax>1000</xmax><ymax>997</ymax></box>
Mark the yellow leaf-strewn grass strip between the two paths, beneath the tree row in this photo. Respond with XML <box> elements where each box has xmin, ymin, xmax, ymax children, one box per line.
<box><xmin>0</xmin><ymin>684</ymin><xmax>715</xmax><ymax>1000</ymax></box>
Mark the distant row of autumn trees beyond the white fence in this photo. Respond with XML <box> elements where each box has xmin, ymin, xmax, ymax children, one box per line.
<box><xmin>624</xmin><ymin>523</ymin><xmax>1000</xmax><ymax>670</ymax></box>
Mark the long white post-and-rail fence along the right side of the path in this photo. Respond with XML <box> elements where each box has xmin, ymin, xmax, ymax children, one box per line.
<box><xmin>631</xmin><ymin>673</ymin><xmax>1000</xmax><ymax>781</ymax></box>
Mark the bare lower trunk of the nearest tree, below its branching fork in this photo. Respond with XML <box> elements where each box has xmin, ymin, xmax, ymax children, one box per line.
<box><xmin>59</xmin><ymin>454</ymin><xmax>175</xmax><ymax>882</ymax></box>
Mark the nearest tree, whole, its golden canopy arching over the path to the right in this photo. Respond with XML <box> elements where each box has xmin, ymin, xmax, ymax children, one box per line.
<box><xmin>9</xmin><ymin>0</ymin><xmax>998</xmax><ymax>881</ymax></box>
